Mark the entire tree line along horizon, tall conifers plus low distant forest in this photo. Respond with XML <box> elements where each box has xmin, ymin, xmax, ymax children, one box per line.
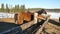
<box><xmin>0</xmin><ymin>3</ymin><xmax>60</xmax><ymax>13</ymax></box>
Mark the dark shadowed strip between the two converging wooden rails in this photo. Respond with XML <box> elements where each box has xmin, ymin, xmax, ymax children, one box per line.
<box><xmin>23</xmin><ymin>21</ymin><xmax>44</xmax><ymax>34</ymax></box>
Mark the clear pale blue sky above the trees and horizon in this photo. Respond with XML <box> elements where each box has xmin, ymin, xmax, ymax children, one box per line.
<box><xmin>0</xmin><ymin>0</ymin><xmax>60</xmax><ymax>8</ymax></box>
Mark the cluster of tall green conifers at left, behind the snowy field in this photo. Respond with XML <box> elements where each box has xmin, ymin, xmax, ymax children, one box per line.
<box><xmin>0</xmin><ymin>3</ymin><xmax>25</xmax><ymax>13</ymax></box>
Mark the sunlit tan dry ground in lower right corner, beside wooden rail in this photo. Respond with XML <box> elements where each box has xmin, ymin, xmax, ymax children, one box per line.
<box><xmin>42</xmin><ymin>22</ymin><xmax>60</xmax><ymax>34</ymax></box>
